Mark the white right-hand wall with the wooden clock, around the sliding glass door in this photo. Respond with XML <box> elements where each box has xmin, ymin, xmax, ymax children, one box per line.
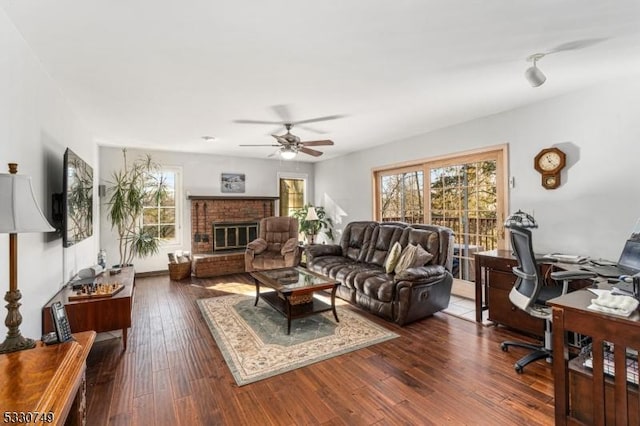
<box><xmin>315</xmin><ymin>76</ymin><xmax>640</xmax><ymax>260</ymax></box>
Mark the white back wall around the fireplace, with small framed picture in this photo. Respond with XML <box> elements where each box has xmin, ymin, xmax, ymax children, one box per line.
<box><xmin>100</xmin><ymin>147</ymin><xmax>314</xmax><ymax>272</ymax></box>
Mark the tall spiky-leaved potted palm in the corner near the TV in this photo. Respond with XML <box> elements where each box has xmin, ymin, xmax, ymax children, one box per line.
<box><xmin>107</xmin><ymin>149</ymin><xmax>167</xmax><ymax>266</ymax></box>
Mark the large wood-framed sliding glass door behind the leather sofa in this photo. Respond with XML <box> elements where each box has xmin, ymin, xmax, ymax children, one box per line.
<box><xmin>373</xmin><ymin>146</ymin><xmax>507</xmax><ymax>280</ymax></box>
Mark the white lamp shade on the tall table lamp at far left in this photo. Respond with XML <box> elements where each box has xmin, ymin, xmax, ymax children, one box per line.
<box><xmin>0</xmin><ymin>173</ymin><xmax>55</xmax><ymax>234</ymax></box>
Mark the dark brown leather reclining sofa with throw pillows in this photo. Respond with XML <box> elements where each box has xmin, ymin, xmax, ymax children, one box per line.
<box><xmin>305</xmin><ymin>221</ymin><xmax>453</xmax><ymax>325</ymax></box>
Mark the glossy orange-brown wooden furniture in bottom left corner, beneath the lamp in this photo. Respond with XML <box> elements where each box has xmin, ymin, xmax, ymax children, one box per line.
<box><xmin>0</xmin><ymin>331</ymin><xmax>96</xmax><ymax>425</ymax></box>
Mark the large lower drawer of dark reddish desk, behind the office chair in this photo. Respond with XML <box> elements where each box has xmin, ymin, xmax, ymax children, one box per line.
<box><xmin>489</xmin><ymin>287</ymin><xmax>544</xmax><ymax>336</ymax></box>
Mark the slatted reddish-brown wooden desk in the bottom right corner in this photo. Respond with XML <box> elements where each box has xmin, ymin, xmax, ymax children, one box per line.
<box><xmin>548</xmin><ymin>290</ymin><xmax>640</xmax><ymax>425</ymax></box>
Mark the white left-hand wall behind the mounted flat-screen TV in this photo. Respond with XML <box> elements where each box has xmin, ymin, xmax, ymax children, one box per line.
<box><xmin>0</xmin><ymin>9</ymin><xmax>98</xmax><ymax>340</ymax></box>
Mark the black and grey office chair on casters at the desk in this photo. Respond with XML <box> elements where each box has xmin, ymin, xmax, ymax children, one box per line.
<box><xmin>500</xmin><ymin>225</ymin><xmax>597</xmax><ymax>373</ymax></box>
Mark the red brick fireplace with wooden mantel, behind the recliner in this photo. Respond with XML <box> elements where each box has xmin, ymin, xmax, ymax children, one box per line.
<box><xmin>189</xmin><ymin>196</ymin><xmax>278</xmax><ymax>277</ymax></box>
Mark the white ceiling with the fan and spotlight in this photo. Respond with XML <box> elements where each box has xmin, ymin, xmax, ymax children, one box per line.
<box><xmin>0</xmin><ymin>0</ymin><xmax>640</xmax><ymax>161</ymax></box>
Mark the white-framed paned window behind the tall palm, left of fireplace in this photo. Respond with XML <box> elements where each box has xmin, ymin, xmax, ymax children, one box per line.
<box><xmin>142</xmin><ymin>168</ymin><xmax>180</xmax><ymax>243</ymax></box>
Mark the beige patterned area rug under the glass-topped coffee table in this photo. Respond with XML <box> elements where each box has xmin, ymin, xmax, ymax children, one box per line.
<box><xmin>198</xmin><ymin>294</ymin><xmax>399</xmax><ymax>386</ymax></box>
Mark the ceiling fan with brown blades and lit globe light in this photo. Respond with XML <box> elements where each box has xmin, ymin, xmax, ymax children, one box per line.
<box><xmin>235</xmin><ymin>105</ymin><xmax>343</xmax><ymax>160</ymax></box>
